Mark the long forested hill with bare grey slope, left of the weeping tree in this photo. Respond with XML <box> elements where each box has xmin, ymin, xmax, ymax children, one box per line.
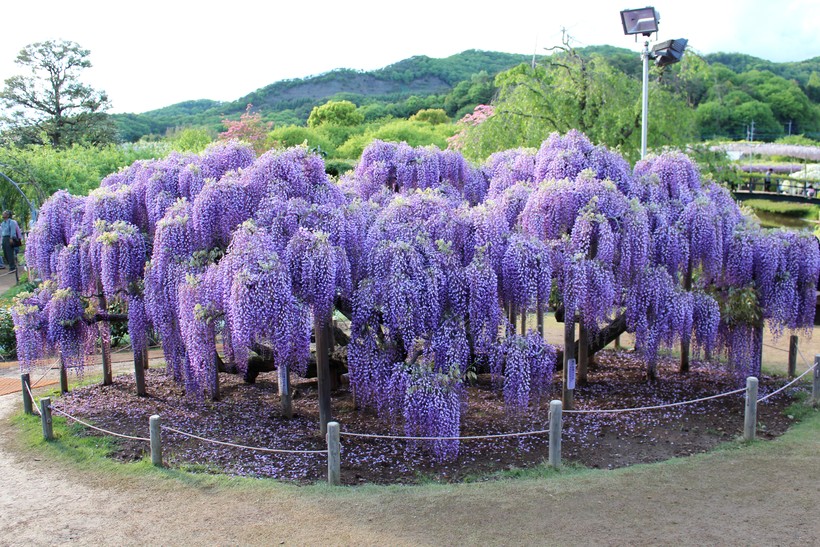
<box><xmin>113</xmin><ymin>50</ymin><xmax>530</xmax><ymax>140</ymax></box>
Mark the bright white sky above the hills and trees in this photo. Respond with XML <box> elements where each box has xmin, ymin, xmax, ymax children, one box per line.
<box><xmin>0</xmin><ymin>0</ymin><xmax>820</xmax><ymax>112</ymax></box>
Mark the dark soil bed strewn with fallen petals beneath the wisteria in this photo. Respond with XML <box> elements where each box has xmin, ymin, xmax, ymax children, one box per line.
<box><xmin>55</xmin><ymin>351</ymin><xmax>794</xmax><ymax>484</ymax></box>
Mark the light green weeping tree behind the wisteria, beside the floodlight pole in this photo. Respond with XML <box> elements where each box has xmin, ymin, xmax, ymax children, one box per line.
<box><xmin>462</xmin><ymin>37</ymin><xmax>696</xmax><ymax>160</ymax></box>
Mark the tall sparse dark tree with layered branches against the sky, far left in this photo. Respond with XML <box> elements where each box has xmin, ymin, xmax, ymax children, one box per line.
<box><xmin>0</xmin><ymin>40</ymin><xmax>116</xmax><ymax>147</ymax></box>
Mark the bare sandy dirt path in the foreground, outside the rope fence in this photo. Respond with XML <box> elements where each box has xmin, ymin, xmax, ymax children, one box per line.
<box><xmin>0</xmin><ymin>396</ymin><xmax>820</xmax><ymax>545</ymax></box>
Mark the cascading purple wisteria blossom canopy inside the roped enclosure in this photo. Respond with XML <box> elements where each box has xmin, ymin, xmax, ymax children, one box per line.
<box><xmin>12</xmin><ymin>131</ymin><xmax>820</xmax><ymax>459</ymax></box>
